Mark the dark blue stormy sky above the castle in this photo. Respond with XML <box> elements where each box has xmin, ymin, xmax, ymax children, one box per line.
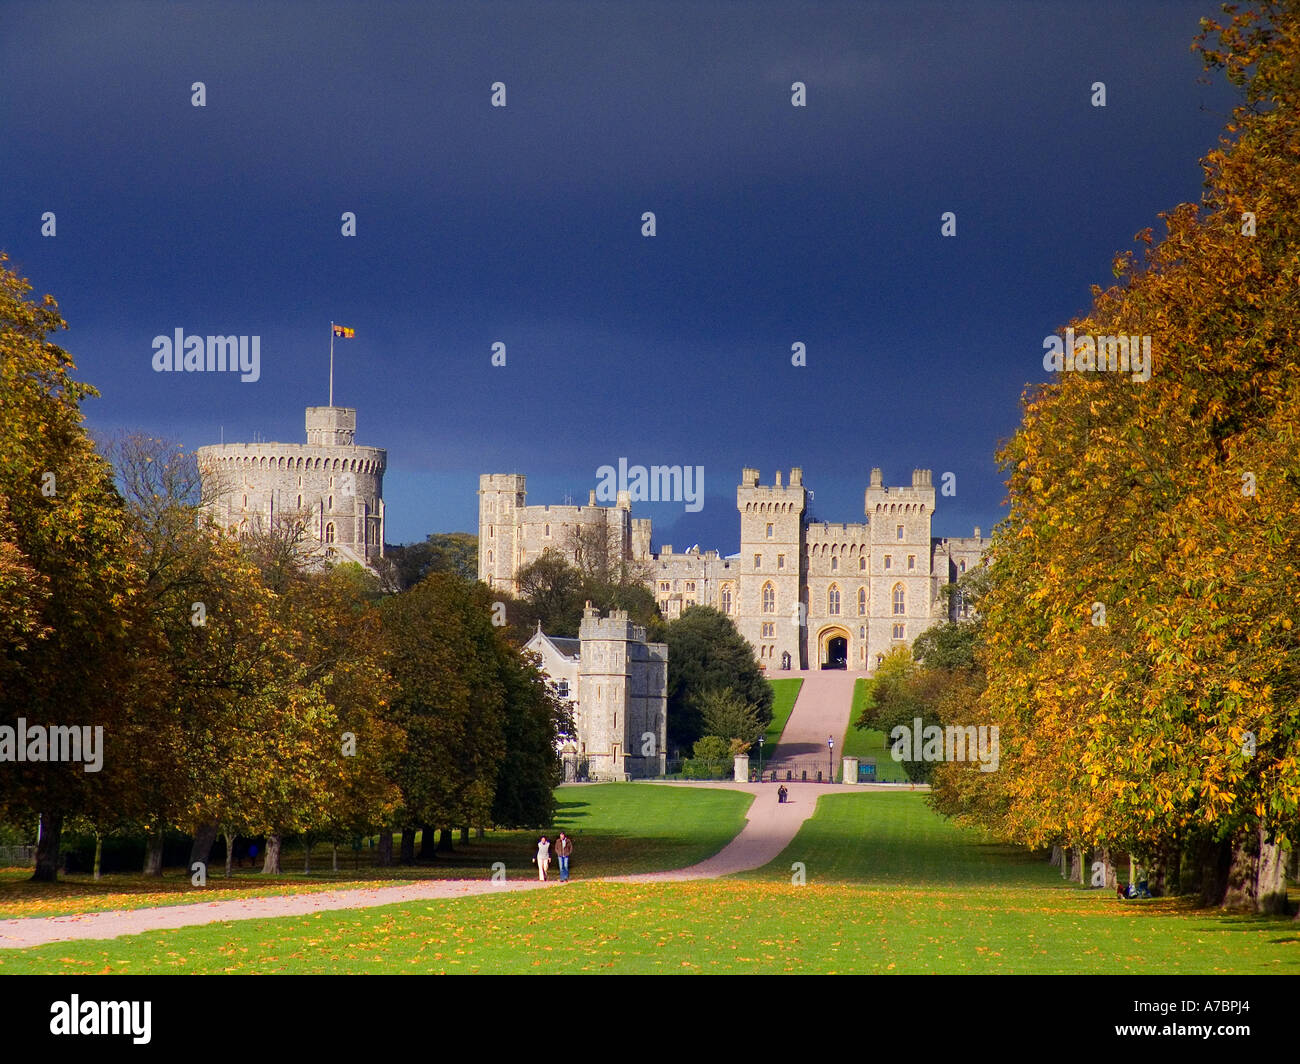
<box><xmin>0</xmin><ymin>0</ymin><xmax>1232</xmax><ymax>552</ymax></box>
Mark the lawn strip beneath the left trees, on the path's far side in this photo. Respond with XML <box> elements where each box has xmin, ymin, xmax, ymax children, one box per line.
<box><xmin>0</xmin><ymin>783</ymin><xmax>753</xmax><ymax>920</ymax></box>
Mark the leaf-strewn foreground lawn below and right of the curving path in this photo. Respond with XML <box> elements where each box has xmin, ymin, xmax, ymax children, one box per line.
<box><xmin>0</xmin><ymin>784</ymin><xmax>1300</xmax><ymax>974</ymax></box>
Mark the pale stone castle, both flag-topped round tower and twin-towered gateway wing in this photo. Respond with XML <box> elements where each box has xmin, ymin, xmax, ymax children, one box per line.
<box><xmin>189</xmin><ymin>406</ymin><xmax>988</xmax><ymax>671</ymax></box>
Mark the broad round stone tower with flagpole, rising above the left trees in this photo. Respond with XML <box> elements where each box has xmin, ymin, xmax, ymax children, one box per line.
<box><xmin>198</xmin><ymin>406</ymin><xmax>387</xmax><ymax>566</ymax></box>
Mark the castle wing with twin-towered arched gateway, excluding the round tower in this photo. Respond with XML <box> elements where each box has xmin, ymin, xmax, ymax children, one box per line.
<box><xmin>478</xmin><ymin>468</ymin><xmax>988</xmax><ymax>672</ymax></box>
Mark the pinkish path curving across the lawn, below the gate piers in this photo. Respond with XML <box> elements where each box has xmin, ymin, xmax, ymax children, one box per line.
<box><xmin>0</xmin><ymin>782</ymin><xmax>888</xmax><ymax>950</ymax></box>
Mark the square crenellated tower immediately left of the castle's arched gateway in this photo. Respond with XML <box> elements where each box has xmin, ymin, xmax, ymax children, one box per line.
<box><xmin>735</xmin><ymin>468</ymin><xmax>807</xmax><ymax>671</ymax></box>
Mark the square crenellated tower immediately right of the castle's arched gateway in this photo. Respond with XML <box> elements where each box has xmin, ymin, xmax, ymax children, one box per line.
<box><xmin>865</xmin><ymin>470</ymin><xmax>935</xmax><ymax>669</ymax></box>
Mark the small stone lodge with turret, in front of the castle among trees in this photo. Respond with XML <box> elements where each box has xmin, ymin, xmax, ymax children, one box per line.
<box><xmin>524</xmin><ymin>606</ymin><xmax>668</xmax><ymax>780</ymax></box>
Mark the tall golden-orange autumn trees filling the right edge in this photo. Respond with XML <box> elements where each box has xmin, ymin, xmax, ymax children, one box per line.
<box><xmin>963</xmin><ymin>3</ymin><xmax>1300</xmax><ymax>911</ymax></box>
